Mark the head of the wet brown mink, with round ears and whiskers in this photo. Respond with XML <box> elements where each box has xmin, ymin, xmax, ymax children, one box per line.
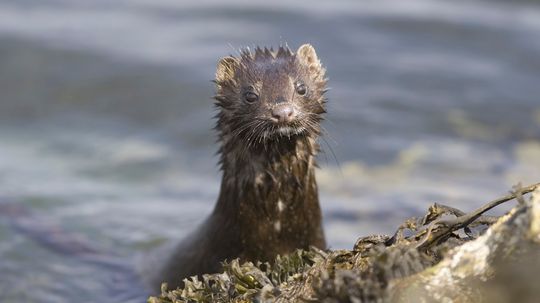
<box><xmin>215</xmin><ymin>44</ymin><xmax>326</xmax><ymax>144</ymax></box>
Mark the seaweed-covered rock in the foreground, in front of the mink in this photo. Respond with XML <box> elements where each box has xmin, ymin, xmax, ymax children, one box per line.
<box><xmin>148</xmin><ymin>184</ymin><xmax>540</xmax><ymax>303</ymax></box>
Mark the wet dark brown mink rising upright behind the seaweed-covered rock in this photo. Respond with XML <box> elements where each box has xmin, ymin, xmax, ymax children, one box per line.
<box><xmin>154</xmin><ymin>44</ymin><xmax>326</xmax><ymax>288</ymax></box>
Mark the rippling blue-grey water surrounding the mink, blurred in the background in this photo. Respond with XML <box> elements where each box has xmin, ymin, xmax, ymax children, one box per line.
<box><xmin>0</xmin><ymin>0</ymin><xmax>540</xmax><ymax>302</ymax></box>
